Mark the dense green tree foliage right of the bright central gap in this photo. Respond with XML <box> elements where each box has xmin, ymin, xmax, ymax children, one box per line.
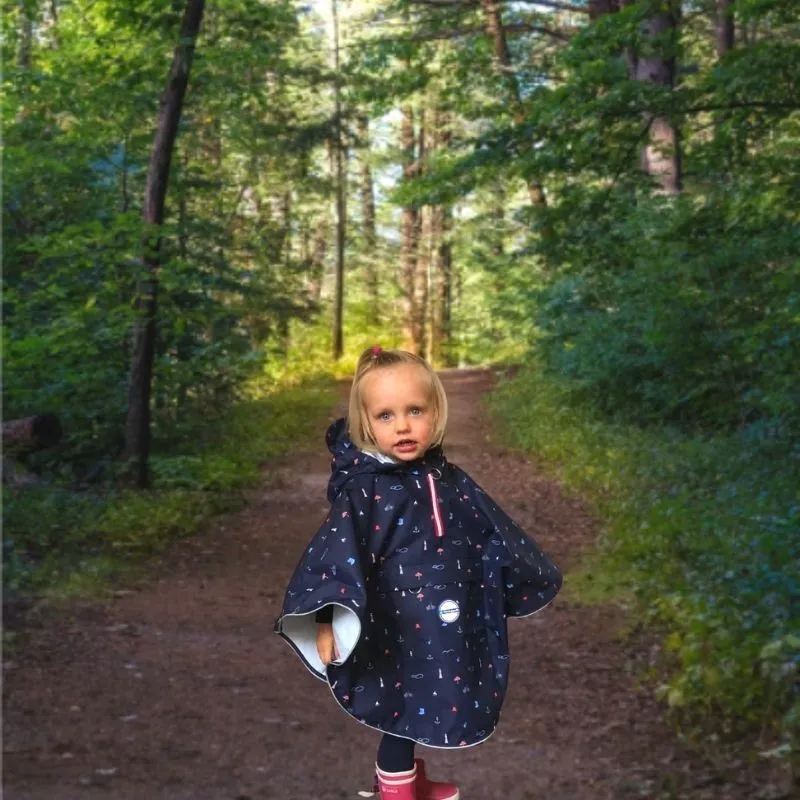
<box><xmin>424</xmin><ymin>3</ymin><xmax>800</xmax><ymax>434</ymax></box>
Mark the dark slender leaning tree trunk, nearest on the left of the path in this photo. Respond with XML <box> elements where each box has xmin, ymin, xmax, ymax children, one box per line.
<box><xmin>124</xmin><ymin>0</ymin><xmax>205</xmax><ymax>488</ymax></box>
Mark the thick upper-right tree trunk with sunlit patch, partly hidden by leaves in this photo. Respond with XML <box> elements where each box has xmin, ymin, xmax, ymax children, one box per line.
<box><xmin>624</xmin><ymin>0</ymin><xmax>682</xmax><ymax>194</ymax></box>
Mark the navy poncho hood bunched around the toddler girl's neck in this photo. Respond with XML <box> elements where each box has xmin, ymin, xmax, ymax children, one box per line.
<box><xmin>325</xmin><ymin>417</ymin><xmax>447</xmax><ymax>503</ymax></box>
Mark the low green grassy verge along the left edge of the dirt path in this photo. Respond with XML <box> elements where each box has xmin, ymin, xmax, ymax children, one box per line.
<box><xmin>3</xmin><ymin>376</ymin><xmax>335</xmax><ymax>593</ymax></box>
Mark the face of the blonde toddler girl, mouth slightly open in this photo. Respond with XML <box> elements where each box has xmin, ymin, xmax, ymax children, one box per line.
<box><xmin>362</xmin><ymin>364</ymin><xmax>435</xmax><ymax>461</ymax></box>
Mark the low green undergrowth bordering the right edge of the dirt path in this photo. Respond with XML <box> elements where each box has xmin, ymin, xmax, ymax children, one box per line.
<box><xmin>490</xmin><ymin>368</ymin><xmax>800</xmax><ymax>763</ymax></box>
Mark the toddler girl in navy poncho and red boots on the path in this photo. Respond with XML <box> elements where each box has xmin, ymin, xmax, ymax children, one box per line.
<box><xmin>275</xmin><ymin>347</ymin><xmax>561</xmax><ymax>800</ymax></box>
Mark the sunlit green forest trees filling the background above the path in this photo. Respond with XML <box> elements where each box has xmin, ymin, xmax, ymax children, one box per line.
<box><xmin>3</xmin><ymin>0</ymin><xmax>800</xmax><ymax>455</ymax></box>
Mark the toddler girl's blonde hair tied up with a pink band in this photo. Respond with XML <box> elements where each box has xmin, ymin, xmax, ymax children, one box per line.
<box><xmin>347</xmin><ymin>347</ymin><xmax>447</xmax><ymax>452</ymax></box>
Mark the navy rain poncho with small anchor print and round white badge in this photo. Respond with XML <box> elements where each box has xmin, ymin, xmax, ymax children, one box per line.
<box><xmin>275</xmin><ymin>420</ymin><xmax>561</xmax><ymax>747</ymax></box>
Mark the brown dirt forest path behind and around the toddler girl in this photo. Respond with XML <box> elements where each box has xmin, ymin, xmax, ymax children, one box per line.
<box><xmin>4</xmin><ymin>370</ymin><xmax>756</xmax><ymax>800</ymax></box>
